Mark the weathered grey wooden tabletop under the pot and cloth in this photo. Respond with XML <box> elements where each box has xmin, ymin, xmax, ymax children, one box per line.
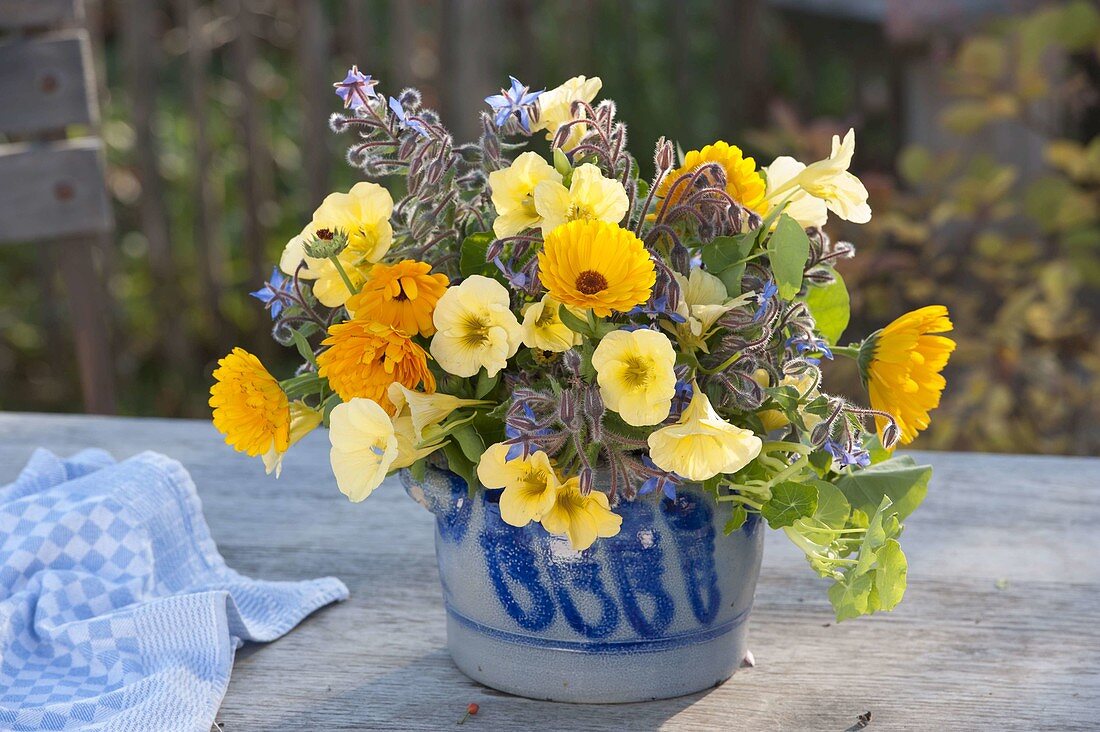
<box><xmin>0</xmin><ymin>414</ymin><xmax>1100</xmax><ymax>732</ymax></box>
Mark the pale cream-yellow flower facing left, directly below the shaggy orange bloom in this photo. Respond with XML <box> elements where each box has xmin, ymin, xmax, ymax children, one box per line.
<box><xmin>329</xmin><ymin>398</ymin><xmax>398</xmax><ymax>503</ymax></box>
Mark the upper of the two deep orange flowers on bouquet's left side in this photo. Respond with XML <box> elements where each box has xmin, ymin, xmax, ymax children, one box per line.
<box><xmin>348</xmin><ymin>260</ymin><xmax>449</xmax><ymax>336</ymax></box>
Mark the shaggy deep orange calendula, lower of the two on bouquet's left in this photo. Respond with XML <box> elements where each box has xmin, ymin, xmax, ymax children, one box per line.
<box><xmin>317</xmin><ymin>320</ymin><xmax>436</xmax><ymax>415</ymax></box>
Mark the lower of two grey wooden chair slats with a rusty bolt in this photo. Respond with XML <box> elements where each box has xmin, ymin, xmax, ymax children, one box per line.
<box><xmin>0</xmin><ymin>139</ymin><xmax>113</xmax><ymax>243</ymax></box>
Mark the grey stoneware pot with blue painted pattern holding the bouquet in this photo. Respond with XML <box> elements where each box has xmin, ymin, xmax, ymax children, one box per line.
<box><xmin>402</xmin><ymin>468</ymin><xmax>763</xmax><ymax>702</ymax></box>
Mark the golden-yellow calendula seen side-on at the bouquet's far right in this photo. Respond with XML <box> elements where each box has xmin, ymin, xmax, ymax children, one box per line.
<box><xmin>859</xmin><ymin>305</ymin><xmax>955</xmax><ymax>445</ymax></box>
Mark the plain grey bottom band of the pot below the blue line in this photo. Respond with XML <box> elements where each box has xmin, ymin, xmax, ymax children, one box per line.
<box><xmin>447</xmin><ymin>611</ymin><xmax>748</xmax><ymax>703</ymax></box>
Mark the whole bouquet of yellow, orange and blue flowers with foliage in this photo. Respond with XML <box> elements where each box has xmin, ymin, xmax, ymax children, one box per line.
<box><xmin>210</xmin><ymin>67</ymin><xmax>955</xmax><ymax>619</ymax></box>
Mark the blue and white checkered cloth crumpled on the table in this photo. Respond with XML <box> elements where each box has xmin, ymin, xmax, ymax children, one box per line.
<box><xmin>0</xmin><ymin>450</ymin><xmax>348</xmax><ymax>732</ymax></box>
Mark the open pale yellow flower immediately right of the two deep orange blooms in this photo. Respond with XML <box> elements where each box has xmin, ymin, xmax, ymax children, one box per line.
<box><xmin>430</xmin><ymin>274</ymin><xmax>524</xmax><ymax>378</ymax></box>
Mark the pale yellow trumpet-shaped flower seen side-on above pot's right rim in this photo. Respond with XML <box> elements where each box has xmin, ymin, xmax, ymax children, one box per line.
<box><xmin>648</xmin><ymin>386</ymin><xmax>763</xmax><ymax>481</ymax></box>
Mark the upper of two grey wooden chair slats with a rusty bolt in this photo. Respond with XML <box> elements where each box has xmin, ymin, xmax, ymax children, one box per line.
<box><xmin>0</xmin><ymin>31</ymin><xmax>98</xmax><ymax>135</ymax></box>
